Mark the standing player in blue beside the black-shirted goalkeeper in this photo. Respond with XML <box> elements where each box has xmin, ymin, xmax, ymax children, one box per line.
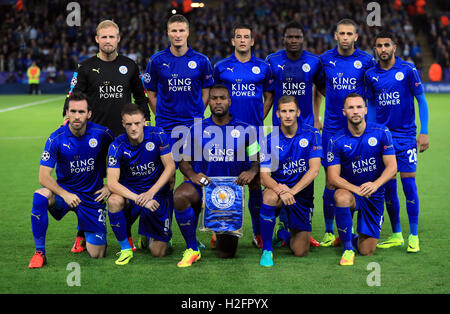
<box><xmin>143</xmin><ymin>14</ymin><xmax>213</xmax><ymax>146</ymax></box>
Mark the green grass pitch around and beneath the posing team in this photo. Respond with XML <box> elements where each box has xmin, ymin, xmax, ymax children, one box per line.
<box><xmin>0</xmin><ymin>94</ymin><xmax>450</xmax><ymax>294</ymax></box>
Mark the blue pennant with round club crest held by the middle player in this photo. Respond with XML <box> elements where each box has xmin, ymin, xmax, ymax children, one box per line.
<box><xmin>200</xmin><ymin>177</ymin><xmax>245</xmax><ymax>237</ymax></box>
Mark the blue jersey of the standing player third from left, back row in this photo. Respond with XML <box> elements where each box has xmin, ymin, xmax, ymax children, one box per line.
<box><xmin>213</xmin><ymin>54</ymin><xmax>273</xmax><ymax>126</ymax></box>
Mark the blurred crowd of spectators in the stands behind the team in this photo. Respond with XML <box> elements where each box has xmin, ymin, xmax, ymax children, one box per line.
<box><xmin>0</xmin><ymin>0</ymin><xmax>449</xmax><ymax>81</ymax></box>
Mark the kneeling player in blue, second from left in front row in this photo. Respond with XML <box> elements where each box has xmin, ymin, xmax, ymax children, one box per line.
<box><xmin>107</xmin><ymin>103</ymin><xmax>175</xmax><ymax>265</ymax></box>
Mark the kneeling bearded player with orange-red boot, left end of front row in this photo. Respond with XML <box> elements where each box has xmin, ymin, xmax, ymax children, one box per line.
<box><xmin>28</xmin><ymin>92</ymin><xmax>114</xmax><ymax>268</ymax></box>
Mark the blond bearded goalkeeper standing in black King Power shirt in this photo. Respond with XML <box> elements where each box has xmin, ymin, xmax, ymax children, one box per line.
<box><xmin>63</xmin><ymin>20</ymin><xmax>150</xmax><ymax>253</ymax></box>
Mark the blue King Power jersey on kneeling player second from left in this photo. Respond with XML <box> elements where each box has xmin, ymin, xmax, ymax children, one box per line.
<box><xmin>108</xmin><ymin>126</ymin><xmax>170</xmax><ymax>195</ymax></box>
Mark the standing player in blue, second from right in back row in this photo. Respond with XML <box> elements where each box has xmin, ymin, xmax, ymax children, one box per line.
<box><xmin>320</xmin><ymin>19</ymin><xmax>375</xmax><ymax>246</ymax></box>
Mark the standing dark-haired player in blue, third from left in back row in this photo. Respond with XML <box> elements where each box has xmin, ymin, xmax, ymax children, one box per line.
<box><xmin>213</xmin><ymin>24</ymin><xmax>273</xmax><ymax>248</ymax></box>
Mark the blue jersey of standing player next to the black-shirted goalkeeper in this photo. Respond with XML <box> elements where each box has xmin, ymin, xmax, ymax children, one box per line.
<box><xmin>142</xmin><ymin>46</ymin><xmax>213</xmax><ymax>134</ymax></box>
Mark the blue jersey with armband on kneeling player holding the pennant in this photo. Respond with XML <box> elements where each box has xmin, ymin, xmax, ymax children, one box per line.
<box><xmin>183</xmin><ymin>117</ymin><xmax>259</xmax><ymax>177</ymax></box>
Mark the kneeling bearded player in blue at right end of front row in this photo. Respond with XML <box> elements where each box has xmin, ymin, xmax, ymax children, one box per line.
<box><xmin>327</xmin><ymin>93</ymin><xmax>397</xmax><ymax>266</ymax></box>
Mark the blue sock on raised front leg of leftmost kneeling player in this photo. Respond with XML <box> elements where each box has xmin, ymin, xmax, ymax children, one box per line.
<box><xmin>31</xmin><ymin>193</ymin><xmax>48</xmax><ymax>255</ymax></box>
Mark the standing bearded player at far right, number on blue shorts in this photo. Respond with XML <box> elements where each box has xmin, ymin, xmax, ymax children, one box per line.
<box><xmin>365</xmin><ymin>31</ymin><xmax>429</xmax><ymax>252</ymax></box>
